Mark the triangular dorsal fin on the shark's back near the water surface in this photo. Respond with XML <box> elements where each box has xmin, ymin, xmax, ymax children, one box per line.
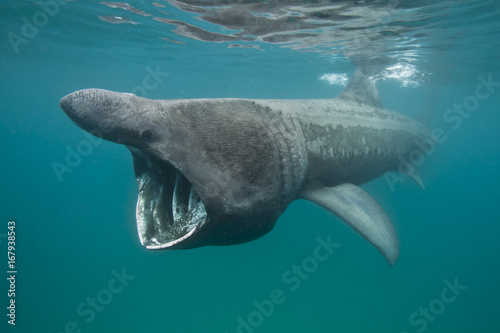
<box><xmin>337</xmin><ymin>69</ymin><xmax>382</xmax><ymax>107</ymax></box>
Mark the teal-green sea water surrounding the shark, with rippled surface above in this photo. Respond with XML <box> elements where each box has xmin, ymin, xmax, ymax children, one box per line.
<box><xmin>0</xmin><ymin>0</ymin><xmax>500</xmax><ymax>333</ymax></box>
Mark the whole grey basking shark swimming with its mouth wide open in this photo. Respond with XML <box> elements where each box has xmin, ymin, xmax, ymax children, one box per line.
<box><xmin>60</xmin><ymin>70</ymin><xmax>431</xmax><ymax>266</ymax></box>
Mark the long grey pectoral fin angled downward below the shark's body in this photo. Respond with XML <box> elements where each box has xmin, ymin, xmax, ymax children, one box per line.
<box><xmin>301</xmin><ymin>184</ymin><xmax>399</xmax><ymax>266</ymax></box>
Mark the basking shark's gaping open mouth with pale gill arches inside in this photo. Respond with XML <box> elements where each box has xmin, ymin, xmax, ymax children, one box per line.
<box><xmin>129</xmin><ymin>147</ymin><xmax>207</xmax><ymax>249</ymax></box>
